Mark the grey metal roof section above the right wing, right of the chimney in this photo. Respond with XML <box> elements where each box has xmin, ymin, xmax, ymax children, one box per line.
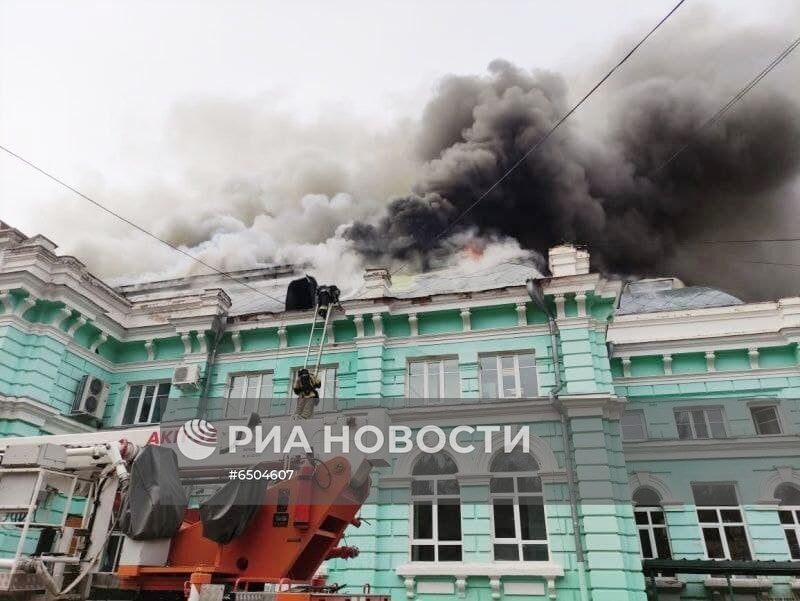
<box><xmin>616</xmin><ymin>278</ymin><xmax>744</xmax><ymax>315</ymax></box>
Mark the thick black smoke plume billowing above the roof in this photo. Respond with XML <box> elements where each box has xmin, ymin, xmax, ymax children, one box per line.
<box><xmin>345</xmin><ymin>53</ymin><xmax>800</xmax><ymax>292</ymax></box>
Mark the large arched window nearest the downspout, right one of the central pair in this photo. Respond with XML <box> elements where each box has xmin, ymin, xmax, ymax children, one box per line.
<box><xmin>490</xmin><ymin>448</ymin><xmax>549</xmax><ymax>561</ymax></box>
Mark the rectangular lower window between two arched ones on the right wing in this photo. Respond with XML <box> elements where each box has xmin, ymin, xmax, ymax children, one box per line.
<box><xmin>692</xmin><ymin>484</ymin><xmax>752</xmax><ymax>561</ymax></box>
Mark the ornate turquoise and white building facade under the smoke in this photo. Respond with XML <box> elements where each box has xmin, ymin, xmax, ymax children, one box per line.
<box><xmin>0</xmin><ymin>225</ymin><xmax>800</xmax><ymax>601</ymax></box>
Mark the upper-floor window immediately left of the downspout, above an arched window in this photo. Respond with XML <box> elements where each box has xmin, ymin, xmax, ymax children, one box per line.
<box><xmin>480</xmin><ymin>353</ymin><xmax>539</xmax><ymax>399</ymax></box>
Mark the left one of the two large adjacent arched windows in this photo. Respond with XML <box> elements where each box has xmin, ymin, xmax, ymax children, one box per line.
<box><xmin>411</xmin><ymin>452</ymin><xmax>461</xmax><ymax>561</ymax></box>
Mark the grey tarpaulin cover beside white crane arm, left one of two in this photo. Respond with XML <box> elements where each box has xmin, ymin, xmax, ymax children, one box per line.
<box><xmin>122</xmin><ymin>445</ymin><xmax>188</xmax><ymax>540</ymax></box>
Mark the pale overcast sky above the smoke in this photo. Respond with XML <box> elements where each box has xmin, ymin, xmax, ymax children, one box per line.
<box><xmin>0</xmin><ymin>0</ymin><xmax>797</xmax><ymax>298</ymax></box>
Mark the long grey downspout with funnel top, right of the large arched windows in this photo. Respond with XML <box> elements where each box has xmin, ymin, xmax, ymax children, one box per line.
<box><xmin>525</xmin><ymin>279</ymin><xmax>589</xmax><ymax>601</ymax></box>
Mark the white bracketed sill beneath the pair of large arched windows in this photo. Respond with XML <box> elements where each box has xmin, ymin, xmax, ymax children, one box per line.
<box><xmin>395</xmin><ymin>561</ymin><xmax>564</xmax><ymax>600</ymax></box>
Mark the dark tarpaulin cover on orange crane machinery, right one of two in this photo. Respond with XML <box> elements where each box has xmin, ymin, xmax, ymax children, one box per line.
<box><xmin>200</xmin><ymin>479</ymin><xmax>267</xmax><ymax>544</ymax></box>
